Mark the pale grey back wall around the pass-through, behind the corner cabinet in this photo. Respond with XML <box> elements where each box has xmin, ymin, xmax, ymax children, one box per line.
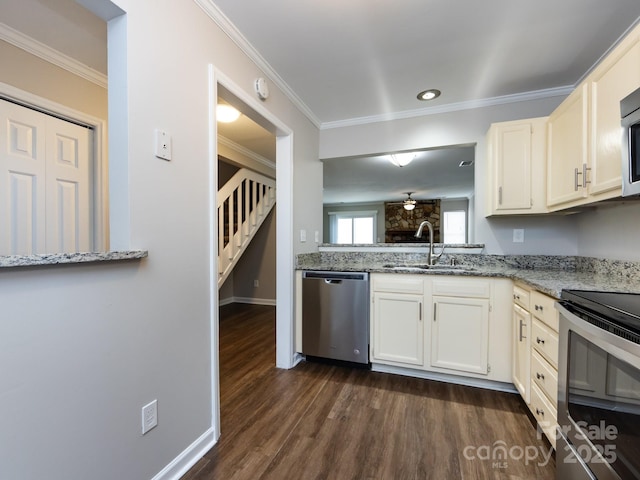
<box><xmin>320</xmin><ymin>97</ymin><xmax>578</xmax><ymax>255</ymax></box>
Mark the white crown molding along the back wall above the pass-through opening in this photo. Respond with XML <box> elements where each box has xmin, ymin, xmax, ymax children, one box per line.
<box><xmin>320</xmin><ymin>85</ymin><xmax>575</xmax><ymax>130</ymax></box>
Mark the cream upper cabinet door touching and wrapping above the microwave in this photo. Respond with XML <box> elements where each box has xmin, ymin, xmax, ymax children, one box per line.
<box><xmin>588</xmin><ymin>39</ymin><xmax>640</xmax><ymax>198</ymax></box>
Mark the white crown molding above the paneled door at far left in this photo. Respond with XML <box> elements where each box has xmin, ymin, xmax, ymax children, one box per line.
<box><xmin>0</xmin><ymin>22</ymin><xmax>107</xmax><ymax>89</ymax></box>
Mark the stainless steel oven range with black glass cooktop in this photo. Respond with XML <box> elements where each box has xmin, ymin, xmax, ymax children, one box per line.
<box><xmin>556</xmin><ymin>290</ymin><xmax>640</xmax><ymax>480</ymax></box>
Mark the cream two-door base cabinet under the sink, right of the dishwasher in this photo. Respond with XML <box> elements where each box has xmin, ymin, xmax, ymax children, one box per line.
<box><xmin>371</xmin><ymin>274</ymin><xmax>511</xmax><ymax>382</ymax></box>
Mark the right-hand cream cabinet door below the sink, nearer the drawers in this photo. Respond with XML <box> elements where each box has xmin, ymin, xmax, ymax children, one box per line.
<box><xmin>431</xmin><ymin>296</ymin><xmax>489</xmax><ymax>374</ymax></box>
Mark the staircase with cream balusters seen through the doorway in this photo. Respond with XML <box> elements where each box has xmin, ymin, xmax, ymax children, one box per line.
<box><xmin>218</xmin><ymin>168</ymin><xmax>276</xmax><ymax>288</ymax></box>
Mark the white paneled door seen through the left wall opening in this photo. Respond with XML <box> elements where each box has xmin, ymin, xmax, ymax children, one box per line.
<box><xmin>0</xmin><ymin>100</ymin><xmax>93</xmax><ymax>255</ymax></box>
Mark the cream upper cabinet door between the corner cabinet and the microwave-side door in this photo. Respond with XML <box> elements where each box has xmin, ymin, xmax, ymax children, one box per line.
<box><xmin>547</xmin><ymin>85</ymin><xmax>588</xmax><ymax>207</ymax></box>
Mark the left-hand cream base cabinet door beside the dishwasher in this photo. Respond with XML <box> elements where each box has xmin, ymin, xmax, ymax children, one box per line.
<box><xmin>371</xmin><ymin>292</ymin><xmax>424</xmax><ymax>366</ymax></box>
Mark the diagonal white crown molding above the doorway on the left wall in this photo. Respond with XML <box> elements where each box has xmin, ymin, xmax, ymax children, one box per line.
<box><xmin>194</xmin><ymin>0</ymin><xmax>321</xmax><ymax>128</ymax></box>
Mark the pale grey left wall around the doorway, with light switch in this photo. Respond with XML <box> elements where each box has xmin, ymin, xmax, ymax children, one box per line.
<box><xmin>0</xmin><ymin>0</ymin><xmax>322</xmax><ymax>480</ymax></box>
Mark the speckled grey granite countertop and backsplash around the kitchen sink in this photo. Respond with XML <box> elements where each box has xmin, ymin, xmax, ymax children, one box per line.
<box><xmin>297</xmin><ymin>253</ymin><xmax>640</xmax><ymax>298</ymax></box>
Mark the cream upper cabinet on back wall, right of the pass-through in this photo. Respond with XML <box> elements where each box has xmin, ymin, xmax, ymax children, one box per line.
<box><xmin>487</xmin><ymin>117</ymin><xmax>547</xmax><ymax>216</ymax></box>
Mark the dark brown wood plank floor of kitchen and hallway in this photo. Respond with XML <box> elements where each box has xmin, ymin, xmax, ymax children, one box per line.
<box><xmin>183</xmin><ymin>304</ymin><xmax>555</xmax><ymax>480</ymax></box>
